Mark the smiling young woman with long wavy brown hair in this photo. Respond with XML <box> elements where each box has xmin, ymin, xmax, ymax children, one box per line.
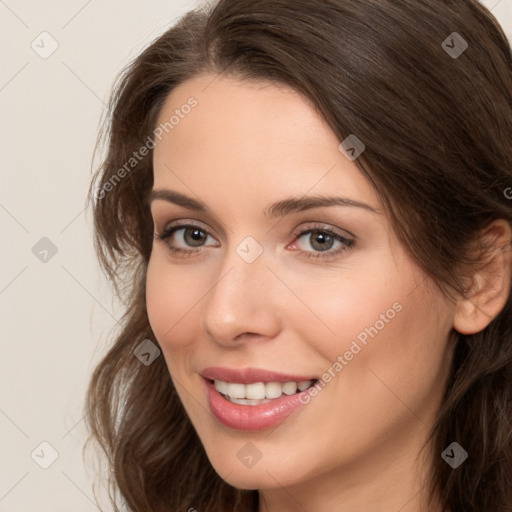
<box><xmin>87</xmin><ymin>0</ymin><xmax>512</xmax><ymax>512</ymax></box>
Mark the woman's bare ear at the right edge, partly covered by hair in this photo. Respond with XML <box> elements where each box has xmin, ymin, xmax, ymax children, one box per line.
<box><xmin>453</xmin><ymin>219</ymin><xmax>512</xmax><ymax>334</ymax></box>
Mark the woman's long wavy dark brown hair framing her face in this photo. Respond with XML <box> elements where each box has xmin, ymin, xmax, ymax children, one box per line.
<box><xmin>86</xmin><ymin>0</ymin><xmax>512</xmax><ymax>512</ymax></box>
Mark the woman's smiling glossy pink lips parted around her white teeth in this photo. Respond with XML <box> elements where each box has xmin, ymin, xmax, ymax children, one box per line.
<box><xmin>201</xmin><ymin>367</ymin><xmax>317</xmax><ymax>431</ymax></box>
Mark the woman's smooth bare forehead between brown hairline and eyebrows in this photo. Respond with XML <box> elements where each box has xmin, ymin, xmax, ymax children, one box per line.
<box><xmin>154</xmin><ymin>75</ymin><xmax>378</xmax><ymax>212</ymax></box>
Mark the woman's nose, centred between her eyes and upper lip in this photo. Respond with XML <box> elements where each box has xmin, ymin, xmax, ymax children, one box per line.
<box><xmin>203</xmin><ymin>241</ymin><xmax>283</xmax><ymax>347</ymax></box>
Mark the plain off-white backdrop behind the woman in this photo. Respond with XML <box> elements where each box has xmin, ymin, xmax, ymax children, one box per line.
<box><xmin>0</xmin><ymin>0</ymin><xmax>512</xmax><ymax>512</ymax></box>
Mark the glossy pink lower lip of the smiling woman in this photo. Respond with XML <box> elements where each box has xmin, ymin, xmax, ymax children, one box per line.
<box><xmin>205</xmin><ymin>379</ymin><xmax>308</xmax><ymax>430</ymax></box>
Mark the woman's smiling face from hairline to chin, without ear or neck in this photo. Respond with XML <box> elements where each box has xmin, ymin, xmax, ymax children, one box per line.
<box><xmin>147</xmin><ymin>76</ymin><xmax>455</xmax><ymax>489</ymax></box>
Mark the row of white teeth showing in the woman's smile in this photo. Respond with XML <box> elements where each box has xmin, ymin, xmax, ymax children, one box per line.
<box><xmin>214</xmin><ymin>380</ymin><xmax>313</xmax><ymax>405</ymax></box>
